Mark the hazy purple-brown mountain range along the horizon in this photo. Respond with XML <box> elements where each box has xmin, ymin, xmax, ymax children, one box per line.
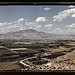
<box><xmin>0</xmin><ymin>29</ymin><xmax>75</xmax><ymax>40</ymax></box>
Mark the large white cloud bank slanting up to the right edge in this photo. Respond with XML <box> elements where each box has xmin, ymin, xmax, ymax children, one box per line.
<box><xmin>53</xmin><ymin>8</ymin><xmax>75</xmax><ymax>21</ymax></box>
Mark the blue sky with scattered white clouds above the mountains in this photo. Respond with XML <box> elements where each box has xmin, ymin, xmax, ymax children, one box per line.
<box><xmin>0</xmin><ymin>5</ymin><xmax>75</xmax><ymax>35</ymax></box>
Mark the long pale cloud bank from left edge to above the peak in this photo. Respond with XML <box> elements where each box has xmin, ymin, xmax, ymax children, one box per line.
<box><xmin>0</xmin><ymin>18</ymin><xmax>42</xmax><ymax>34</ymax></box>
